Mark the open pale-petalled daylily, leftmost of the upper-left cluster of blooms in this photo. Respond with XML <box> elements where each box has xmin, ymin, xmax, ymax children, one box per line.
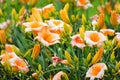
<box><xmin>23</xmin><ymin>21</ymin><xmax>48</xmax><ymax>33</ymax></box>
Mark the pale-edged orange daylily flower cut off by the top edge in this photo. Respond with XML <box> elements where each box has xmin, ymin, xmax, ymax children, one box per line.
<box><xmin>75</xmin><ymin>0</ymin><xmax>92</xmax><ymax>9</ymax></box>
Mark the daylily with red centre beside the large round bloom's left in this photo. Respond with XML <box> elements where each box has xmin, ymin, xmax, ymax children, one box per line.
<box><xmin>71</xmin><ymin>34</ymin><xmax>85</xmax><ymax>48</ymax></box>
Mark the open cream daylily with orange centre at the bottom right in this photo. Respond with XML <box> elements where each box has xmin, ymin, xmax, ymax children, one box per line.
<box><xmin>86</xmin><ymin>63</ymin><xmax>107</xmax><ymax>80</ymax></box>
